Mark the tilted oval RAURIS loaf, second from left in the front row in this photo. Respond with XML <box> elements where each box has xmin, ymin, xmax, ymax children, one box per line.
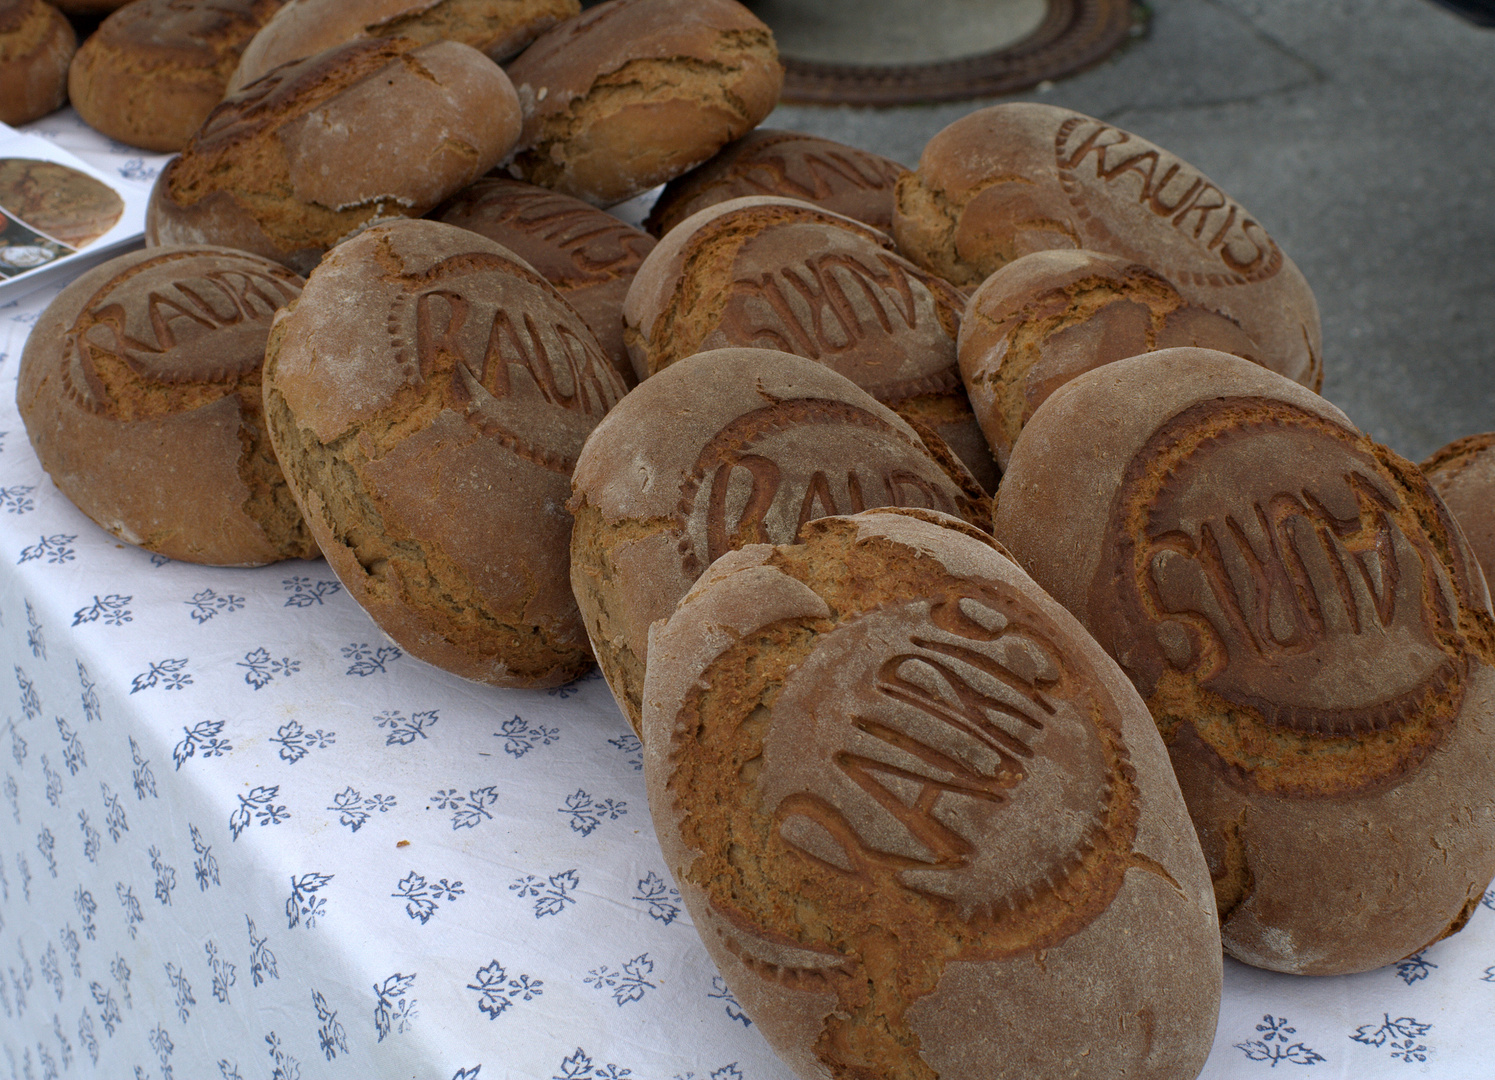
<box><xmin>265</xmin><ymin>218</ymin><xmax>625</xmax><ymax>687</ymax></box>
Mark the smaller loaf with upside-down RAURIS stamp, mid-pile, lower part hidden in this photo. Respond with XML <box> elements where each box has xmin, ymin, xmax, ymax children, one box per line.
<box><xmin>623</xmin><ymin>196</ymin><xmax>999</xmax><ymax>491</ymax></box>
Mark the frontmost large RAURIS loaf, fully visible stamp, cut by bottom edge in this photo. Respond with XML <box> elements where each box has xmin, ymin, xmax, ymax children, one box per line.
<box><xmin>643</xmin><ymin>512</ymin><xmax>1221</xmax><ymax>1080</ymax></box>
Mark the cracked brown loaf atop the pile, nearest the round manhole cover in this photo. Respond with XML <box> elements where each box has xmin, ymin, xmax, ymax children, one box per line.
<box><xmin>508</xmin><ymin>0</ymin><xmax>783</xmax><ymax>206</ymax></box>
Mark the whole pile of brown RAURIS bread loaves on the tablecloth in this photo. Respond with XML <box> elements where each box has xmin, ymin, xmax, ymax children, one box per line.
<box><xmin>11</xmin><ymin>0</ymin><xmax>1495</xmax><ymax>1080</ymax></box>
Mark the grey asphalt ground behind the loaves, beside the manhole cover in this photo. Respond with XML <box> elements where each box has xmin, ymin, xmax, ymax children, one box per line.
<box><xmin>765</xmin><ymin>0</ymin><xmax>1495</xmax><ymax>461</ymax></box>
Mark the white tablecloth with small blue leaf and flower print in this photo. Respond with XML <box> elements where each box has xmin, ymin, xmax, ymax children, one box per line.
<box><xmin>0</xmin><ymin>114</ymin><xmax>1495</xmax><ymax>1080</ymax></box>
